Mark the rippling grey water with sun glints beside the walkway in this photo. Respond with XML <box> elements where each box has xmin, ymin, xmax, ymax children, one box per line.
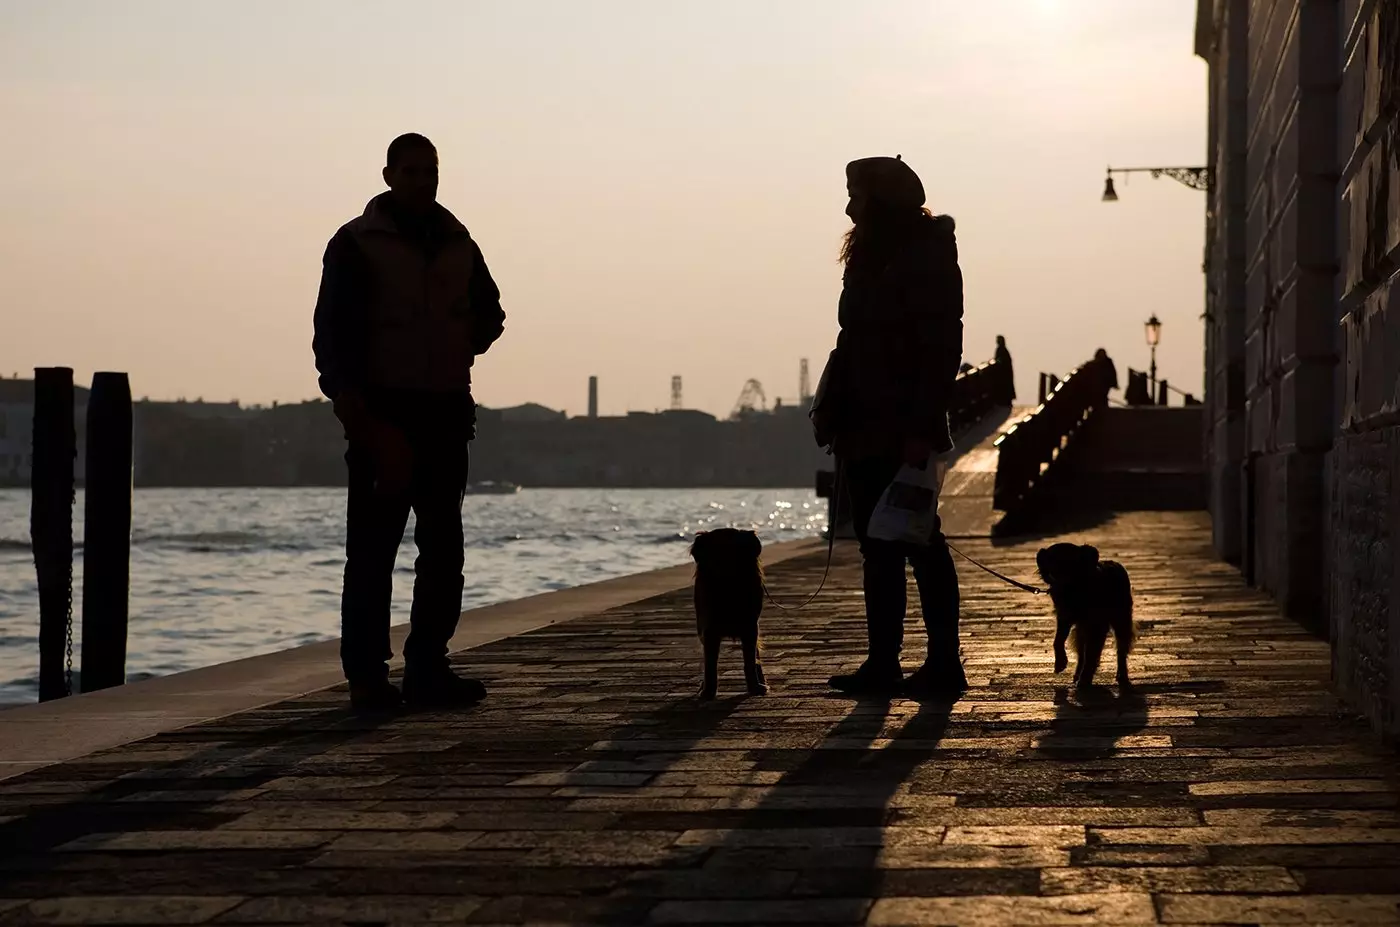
<box><xmin>0</xmin><ymin>489</ymin><xmax>826</xmax><ymax>704</ymax></box>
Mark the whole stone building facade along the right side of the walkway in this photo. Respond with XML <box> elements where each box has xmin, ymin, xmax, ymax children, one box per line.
<box><xmin>1196</xmin><ymin>0</ymin><xmax>1400</xmax><ymax>734</ymax></box>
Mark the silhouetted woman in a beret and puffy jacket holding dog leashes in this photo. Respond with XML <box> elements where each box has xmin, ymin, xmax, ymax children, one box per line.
<box><xmin>812</xmin><ymin>157</ymin><xmax>967</xmax><ymax>695</ymax></box>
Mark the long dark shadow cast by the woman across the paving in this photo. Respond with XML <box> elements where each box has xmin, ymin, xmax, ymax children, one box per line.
<box><xmin>599</xmin><ymin>699</ymin><xmax>952</xmax><ymax>923</ymax></box>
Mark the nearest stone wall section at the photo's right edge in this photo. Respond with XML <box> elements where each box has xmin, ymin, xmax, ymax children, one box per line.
<box><xmin>1329</xmin><ymin>0</ymin><xmax>1400</xmax><ymax>735</ymax></box>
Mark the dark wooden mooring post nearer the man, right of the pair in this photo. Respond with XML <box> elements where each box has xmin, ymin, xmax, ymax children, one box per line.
<box><xmin>81</xmin><ymin>372</ymin><xmax>132</xmax><ymax>692</ymax></box>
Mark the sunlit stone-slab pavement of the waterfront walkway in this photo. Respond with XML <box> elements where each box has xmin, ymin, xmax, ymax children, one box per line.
<box><xmin>0</xmin><ymin>513</ymin><xmax>1400</xmax><ymax>924</ymax></box>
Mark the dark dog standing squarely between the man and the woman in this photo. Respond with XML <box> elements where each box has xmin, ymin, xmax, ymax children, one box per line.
<box><xmin>690</xmin><ymin>528</ymin><xmax>769</xmax><ymax>699</ymax></box>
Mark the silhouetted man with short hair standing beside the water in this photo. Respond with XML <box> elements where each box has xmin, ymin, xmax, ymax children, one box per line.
<box><xmin>312</xmin><ymin>134</ymin><xmax>505</xmax><ymax>711</ymax></box>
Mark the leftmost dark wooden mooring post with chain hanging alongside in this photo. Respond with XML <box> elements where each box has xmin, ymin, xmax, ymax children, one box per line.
<box><xmin>29</xmin><ymin>367</ymin><xmax>77</xmax><ymax>702</ymax></box>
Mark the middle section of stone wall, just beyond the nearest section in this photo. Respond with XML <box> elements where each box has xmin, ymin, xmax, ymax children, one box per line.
<box><xmin>1245</xmin><ymin>0</ymin><xmax>1341</xmax><ymax>632</ymax></box>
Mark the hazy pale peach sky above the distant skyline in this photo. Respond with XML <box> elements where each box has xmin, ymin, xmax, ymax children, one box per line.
<box><xmin>0</xmin><ymin>0</ymin><xmax>1205</xmax><ymax>414</ymax></box>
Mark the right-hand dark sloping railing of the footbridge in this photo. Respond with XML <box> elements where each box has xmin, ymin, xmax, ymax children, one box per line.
<box><xmin>991</xmin><ymin>358</ymin><xmax>1112</xmax><ymax>511</ymax></box>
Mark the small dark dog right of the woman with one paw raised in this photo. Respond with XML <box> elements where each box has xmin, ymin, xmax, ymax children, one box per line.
<box><xmin>1036</xmin><ymin>543</ymin><xmax>1135</xmax><ymax>689</ymax></box>
